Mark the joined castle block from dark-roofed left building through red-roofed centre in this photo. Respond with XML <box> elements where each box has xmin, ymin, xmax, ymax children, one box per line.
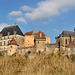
<box><xmin>0</xmin><ymin>23</ymin><xmax>50</xmax><ymax>55</ymax></box>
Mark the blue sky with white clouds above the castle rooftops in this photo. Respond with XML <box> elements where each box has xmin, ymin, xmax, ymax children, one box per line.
<box><xmin>0</xmin><ymin>0</ymin><xmax>75</xmax><ymax>43</ymax></box>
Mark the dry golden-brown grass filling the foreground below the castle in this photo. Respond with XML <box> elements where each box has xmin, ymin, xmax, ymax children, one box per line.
<box><xmin>0</xmin><ymin>53</ymin><xmax>75</xmax><ymax>75</ymax></box>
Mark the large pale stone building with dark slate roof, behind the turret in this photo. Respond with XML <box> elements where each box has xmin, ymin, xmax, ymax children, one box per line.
<box><xmin>0</xmin><ymin>23</ymin><xmax>24</xmax><ymax>51</ymax></box>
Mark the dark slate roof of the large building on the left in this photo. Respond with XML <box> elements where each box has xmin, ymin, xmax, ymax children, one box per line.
<box><xmin>0</xmin><ymin>25</ymin><xmax>23</xmax><ymax>36</ymax></box>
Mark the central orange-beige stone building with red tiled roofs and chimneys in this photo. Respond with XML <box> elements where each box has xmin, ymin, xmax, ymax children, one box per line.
<box><xmin>24</xmin><ymin>30</ymin><xmax>50</xmax><ymax>52</ymax></box>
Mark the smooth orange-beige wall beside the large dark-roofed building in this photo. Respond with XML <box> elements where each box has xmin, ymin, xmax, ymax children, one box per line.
<box><xmin>24</xmin><ymin>35</ymin><xmax>34</xmax><ymax>47</ymax></box>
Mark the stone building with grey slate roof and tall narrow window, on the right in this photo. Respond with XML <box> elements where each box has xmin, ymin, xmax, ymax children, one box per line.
<box><xmin>56</xmin><ymin>30</ymin><xmax>75</xmax><ymax>52</ymax></box>
